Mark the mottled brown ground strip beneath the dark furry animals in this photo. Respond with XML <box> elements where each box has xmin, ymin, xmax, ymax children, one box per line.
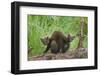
<box><xmin>28</xmin><ymin>48</ymin><xmax>88</xmax><ymax>61</ymax></box>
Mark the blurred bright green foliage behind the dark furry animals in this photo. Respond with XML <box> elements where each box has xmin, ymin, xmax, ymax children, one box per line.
<box><xmin>27</xmin><ymin>15</ymin><xmax>88</xmax><ymax>56</ymax></box>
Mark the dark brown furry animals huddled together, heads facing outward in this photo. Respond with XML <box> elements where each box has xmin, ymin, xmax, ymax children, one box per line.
<box><xmin>41</xmin><ymin>31</ymin><xmax>75</xmax><ymax>54</ymax></box>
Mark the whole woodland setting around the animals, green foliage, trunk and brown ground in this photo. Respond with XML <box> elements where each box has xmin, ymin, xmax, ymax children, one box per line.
<box><xmin>27</xmin><ymin>15</ymin><xmax>88</xmax><ymax>60</ymax></box>
